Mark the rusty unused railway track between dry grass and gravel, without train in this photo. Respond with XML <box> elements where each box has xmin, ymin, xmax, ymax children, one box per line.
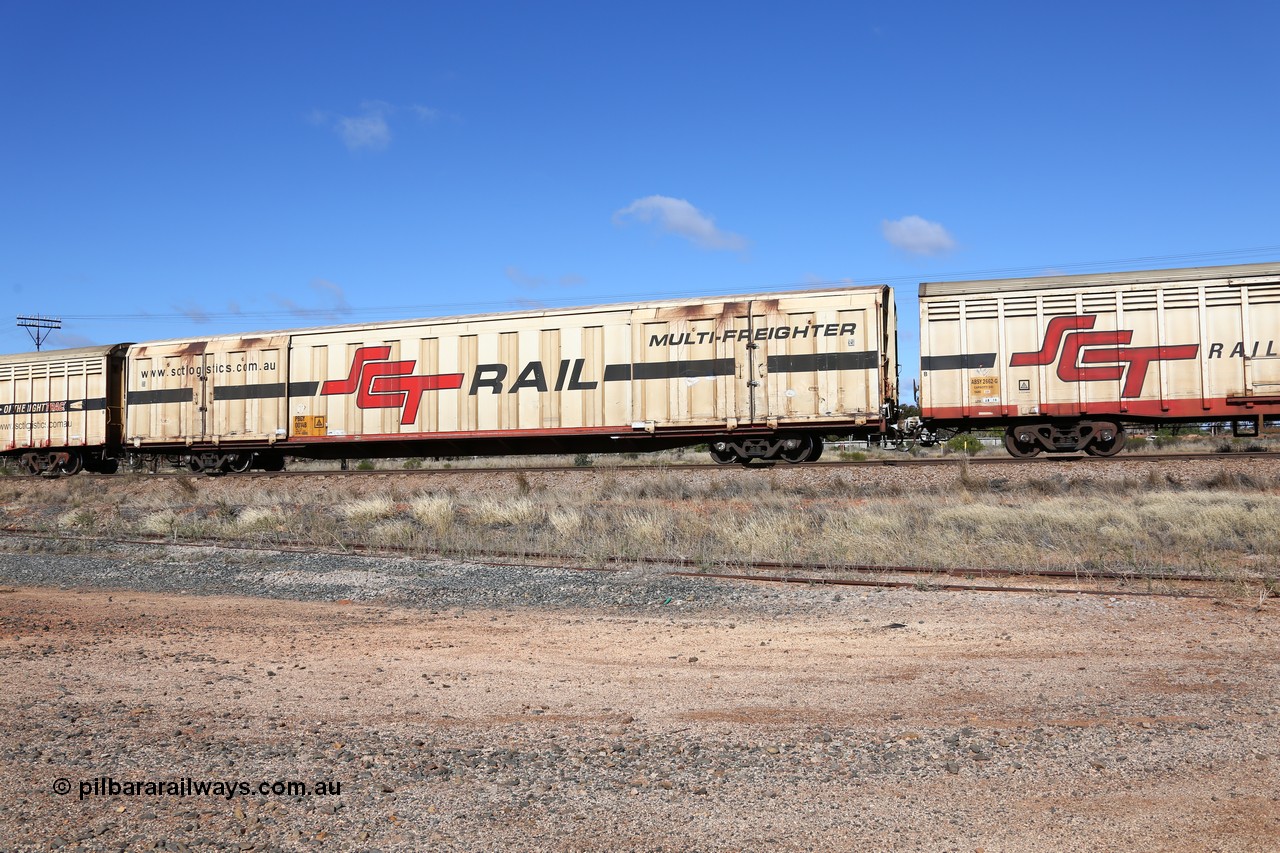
<box><xmin>0</xmin><ymin>525</ymin><xmax>1244</xmax><ymax>598</ymax></box>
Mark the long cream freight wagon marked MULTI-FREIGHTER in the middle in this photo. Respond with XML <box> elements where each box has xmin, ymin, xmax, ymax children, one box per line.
<box><xmin>125</xmin><ymin>287</ymin><xmax>897</xmax><ymax>470</ymax></box>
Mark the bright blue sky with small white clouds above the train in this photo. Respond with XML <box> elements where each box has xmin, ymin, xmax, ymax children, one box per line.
<box><xmin>0</xmin><ymin>0</ymin><xmax>1280</xmax><ymax>389</ymax></box>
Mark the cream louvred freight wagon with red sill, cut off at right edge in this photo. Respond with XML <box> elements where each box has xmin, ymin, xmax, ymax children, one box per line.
<box><xmin>919</xmin><ymin>264</ymin><xmax>1280</xmax><ymax>456</ymax></box>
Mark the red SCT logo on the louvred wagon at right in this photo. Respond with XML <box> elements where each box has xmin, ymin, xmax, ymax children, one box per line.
<box><xmin>1009</xmin><ymin>315</ymin><xmax>1199</xmax><ymax>397</ymax></box>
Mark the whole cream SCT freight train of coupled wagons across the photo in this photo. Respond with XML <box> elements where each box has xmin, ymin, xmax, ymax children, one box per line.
<box><xmin>0</xmin><ymin>258</ymin><xmax>1280</xmax><ymax>474</ymax></box>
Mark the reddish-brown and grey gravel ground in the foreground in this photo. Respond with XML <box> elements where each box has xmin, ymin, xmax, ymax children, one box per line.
<box><xmin>0</xmin><ymin>538</ymin><xmax>1280</xmax><ymax>850</ymax></box>
